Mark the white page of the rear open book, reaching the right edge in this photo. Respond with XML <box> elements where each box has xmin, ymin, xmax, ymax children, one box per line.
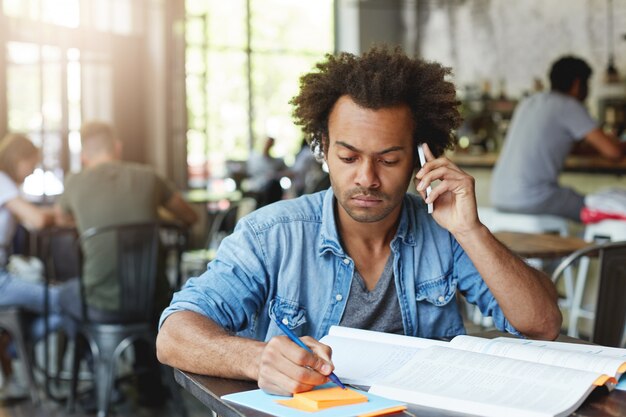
<box><xmin>450</xmin><ymin>336</ymin><xmax>624</xmax><ymax>379</ymax></box>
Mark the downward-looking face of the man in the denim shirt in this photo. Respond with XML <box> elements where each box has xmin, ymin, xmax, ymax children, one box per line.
<box><xmin>325</xmin><ymin>96</ymin><xmax>415</xmax><ymax>223</ymax></box>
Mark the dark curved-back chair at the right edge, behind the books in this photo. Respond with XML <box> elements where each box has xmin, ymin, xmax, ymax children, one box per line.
<box><xmin>552</xmin><ymin>241</ymin><xmax>626</xmax><ymax>347</ymax></box>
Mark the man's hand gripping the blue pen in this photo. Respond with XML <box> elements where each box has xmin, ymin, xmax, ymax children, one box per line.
<box><xmin>257</xmin><ymin>336</ymin><xmax>334</xmax><ymax>395</ymax></box>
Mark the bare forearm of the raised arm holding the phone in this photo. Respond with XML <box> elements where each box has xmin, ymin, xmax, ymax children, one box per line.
<box><xmin>450</xmin><ymin>226</ymin><xmax>562</xmax><ymax>339</ymax></box>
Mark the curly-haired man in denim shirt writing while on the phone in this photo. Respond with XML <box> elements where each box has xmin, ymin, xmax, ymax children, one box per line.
<box><xmin>157</xmin><ymin>48</ymin><xmax>561</xmax><ymax>394</ymax></box>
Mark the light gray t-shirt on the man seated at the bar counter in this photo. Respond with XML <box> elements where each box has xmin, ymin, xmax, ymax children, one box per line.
<box><xmin>491</xmin><ymin>92</ymin><xmax>597</xmax><ymax>211</ymax></box>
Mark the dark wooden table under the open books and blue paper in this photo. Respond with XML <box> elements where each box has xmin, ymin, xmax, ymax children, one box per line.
<box><xmin>174</xmin><ymin>331</ymin><xmax>626</xmax><ymax>417</ymax></box>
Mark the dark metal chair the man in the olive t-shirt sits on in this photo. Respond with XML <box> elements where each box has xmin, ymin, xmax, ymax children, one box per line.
<box><xmin>68</xmin><ymin>223</ymin><xmax>159</xmax><ymax>417</ymax></box>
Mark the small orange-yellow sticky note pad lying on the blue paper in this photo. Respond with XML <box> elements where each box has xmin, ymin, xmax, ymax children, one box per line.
<box><xmin>277</xmin><ymin>387</ymin><xmax>367</xmax><ymax>411</ymax></box>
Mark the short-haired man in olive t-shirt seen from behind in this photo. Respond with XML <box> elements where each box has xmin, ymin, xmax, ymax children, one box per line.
<box><xmin>55</xmin><ymin>121</ymin><xmax>197</xmax><ymax>405</ymax></box>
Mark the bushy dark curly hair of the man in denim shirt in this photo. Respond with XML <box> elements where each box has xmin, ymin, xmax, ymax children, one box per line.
<box><xmin>290</xmin><ymin>46</ymin><xmax>461</xmax><ymax>158</ymax></box>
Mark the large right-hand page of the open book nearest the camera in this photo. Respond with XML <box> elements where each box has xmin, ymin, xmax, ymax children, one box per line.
<box><xmin>370</xmin><ymin>346</ymin><xmax>599</xmax><ymax>417</ymax></box>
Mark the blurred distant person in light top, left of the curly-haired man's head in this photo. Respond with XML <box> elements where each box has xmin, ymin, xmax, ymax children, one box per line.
<box><xmin>246</xmin><ymin>136</ymin><xmax>287</xmax><ymax>207</ymax></box>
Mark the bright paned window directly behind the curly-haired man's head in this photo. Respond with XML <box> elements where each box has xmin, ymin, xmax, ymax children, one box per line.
<box><xmin>186</xmin><ymin>0</ymin><xmax>334</xmax><ymax>187</ymax></box>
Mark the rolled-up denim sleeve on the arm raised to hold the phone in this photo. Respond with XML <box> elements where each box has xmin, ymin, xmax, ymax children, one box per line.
<box><xmin>453</xmin><ymin>236</ymin><xmax>522</xmax><ymax>336</ymax></box>
